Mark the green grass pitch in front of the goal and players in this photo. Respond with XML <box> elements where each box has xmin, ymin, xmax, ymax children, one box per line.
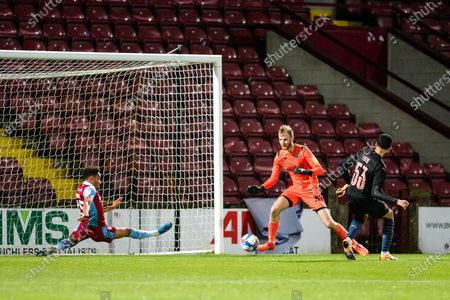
<box><xmin>0</xmin><ymin>254</ymin><xmax>450</xmax><ymax>300</ymax></box>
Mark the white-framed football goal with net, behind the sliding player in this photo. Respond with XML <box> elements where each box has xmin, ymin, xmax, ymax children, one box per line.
<box><xmin>0</xmin><ymin>51</ymin><xmax>223</xmax><ymax>255</ymax></box>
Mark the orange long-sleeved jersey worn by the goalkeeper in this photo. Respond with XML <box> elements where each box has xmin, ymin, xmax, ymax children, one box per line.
<box><xmin>263</xmin><ymin>144</ymin><xmax>325</xmax><ymax>191</ymax></box>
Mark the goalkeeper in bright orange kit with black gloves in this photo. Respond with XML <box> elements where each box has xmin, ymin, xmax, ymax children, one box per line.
<box><xmin>247</xmin><ymin>125</ymin><xmax>368</xmax><ymax>259</ymax></box>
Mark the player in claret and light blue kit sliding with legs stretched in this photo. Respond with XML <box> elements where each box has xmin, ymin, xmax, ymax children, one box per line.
<box><xmin>36</xmin><ymin>168</ymin><xmax>172</xmax><ymax>256</ymax></box>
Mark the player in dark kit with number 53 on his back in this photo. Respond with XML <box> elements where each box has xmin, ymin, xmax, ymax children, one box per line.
<box><xmin>336</xmin><ymin>134</ymin><xmax>409</xmax><ymax>260</ymax></box>
